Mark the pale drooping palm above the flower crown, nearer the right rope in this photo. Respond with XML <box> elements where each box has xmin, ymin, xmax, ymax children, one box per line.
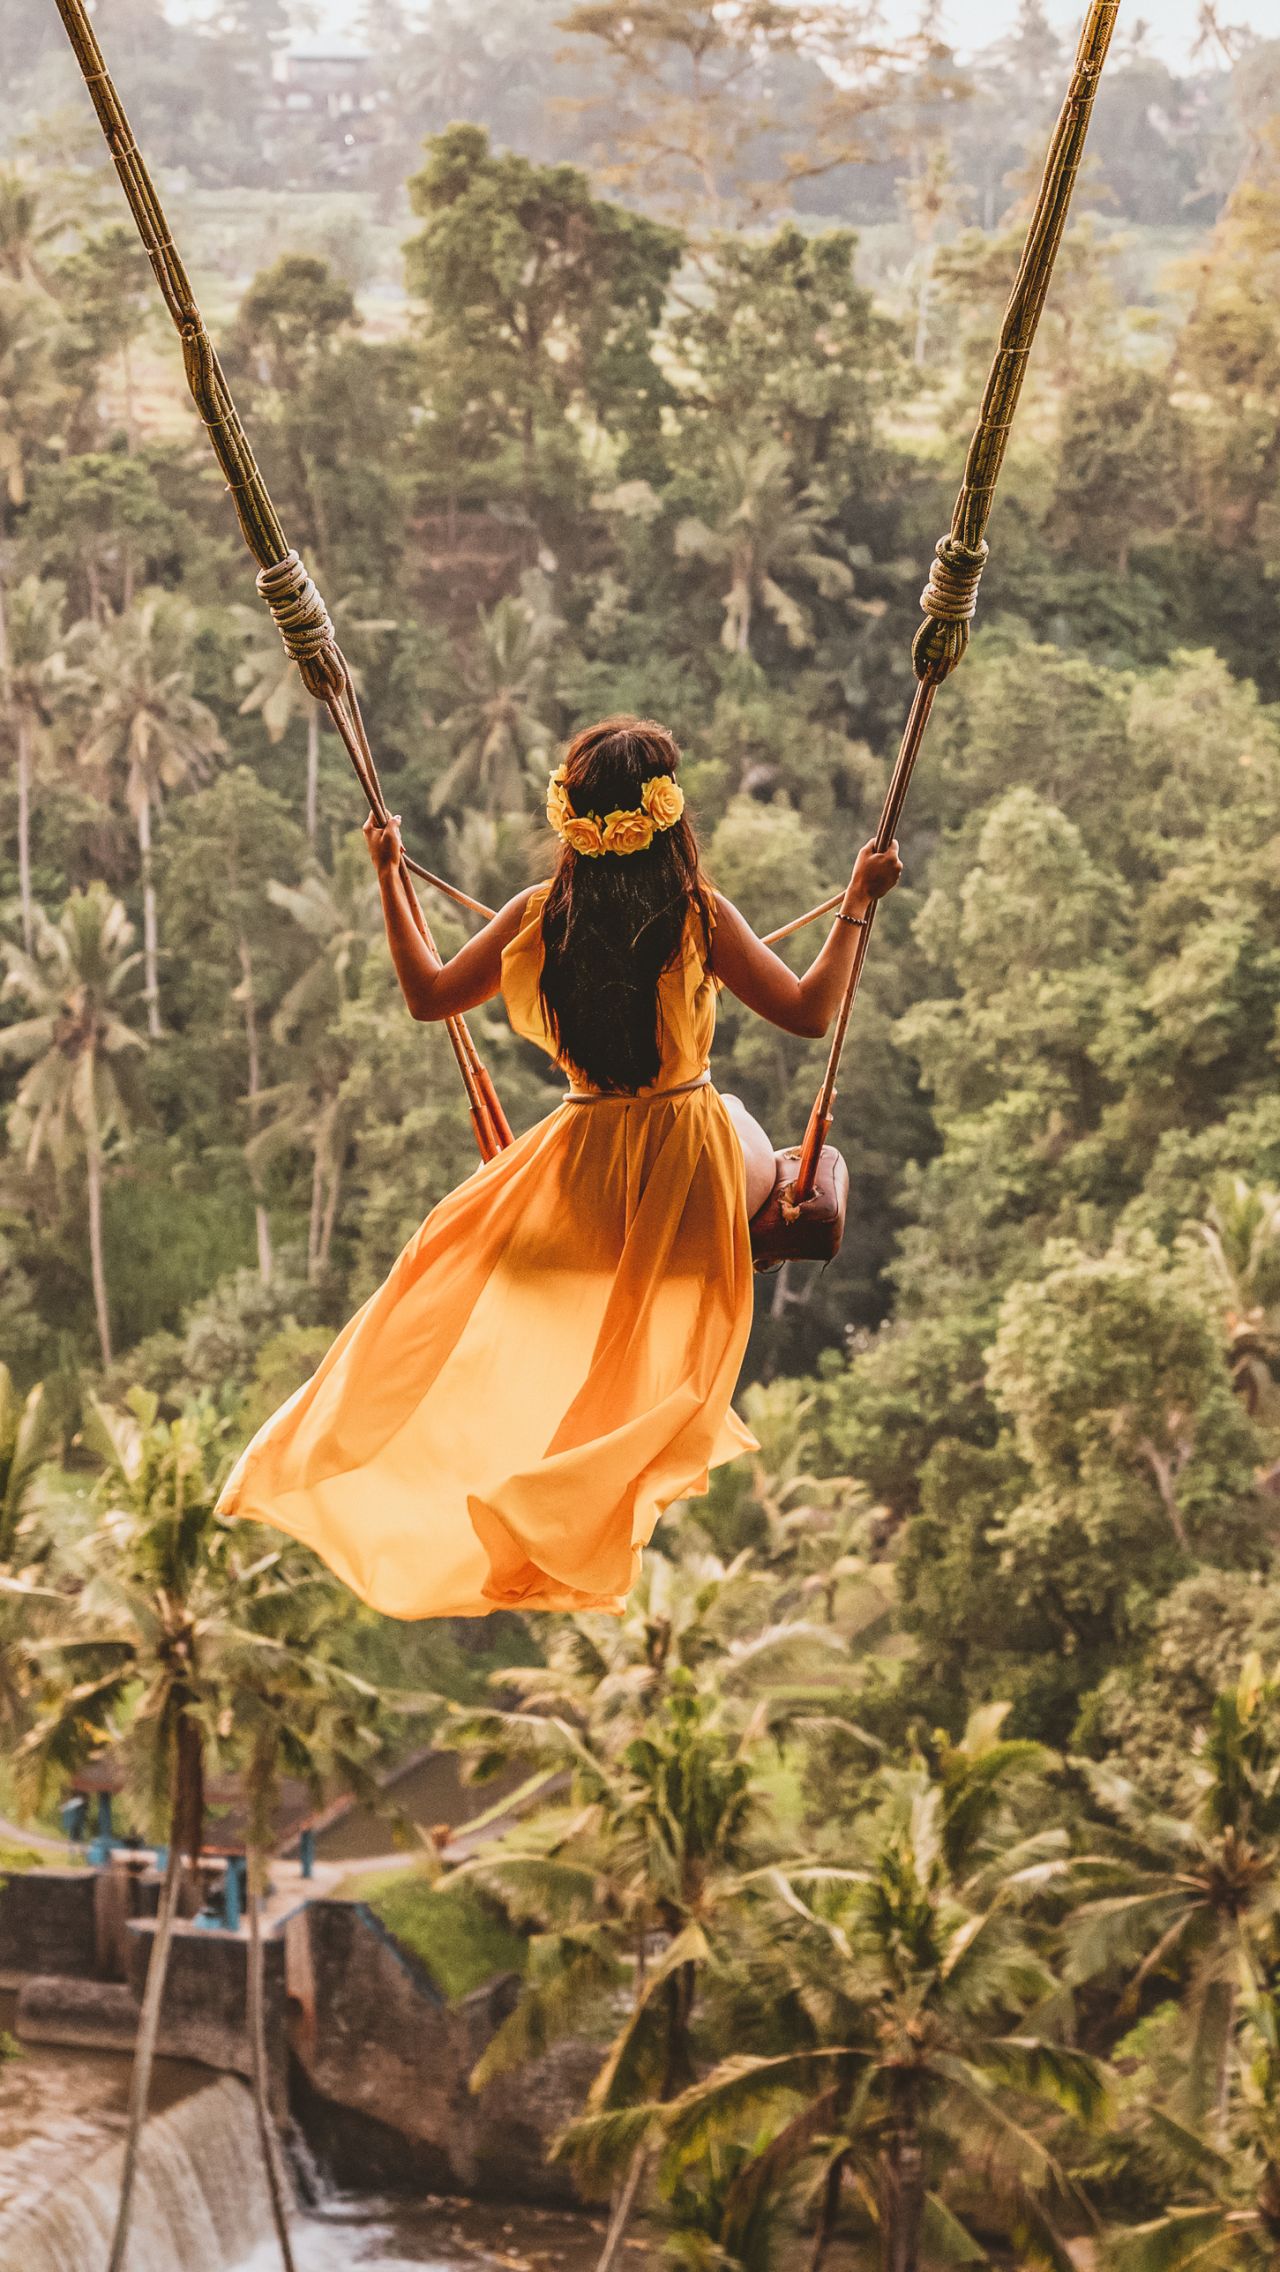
<box><xmin>675</xmin><ymin>441</ymin><xmax>853</xmax><ymax>654</ymax></box>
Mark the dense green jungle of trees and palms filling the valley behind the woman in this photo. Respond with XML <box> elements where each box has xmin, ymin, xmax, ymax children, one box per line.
<box><xmin>0</xmin><ymin>44</ymin><xmax>1280</xmax><ymax>2272</ymax></box>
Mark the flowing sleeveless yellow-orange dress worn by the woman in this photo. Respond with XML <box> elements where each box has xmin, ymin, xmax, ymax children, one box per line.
<box><xmin>221</xmin><ymin>886</ymin><xmax>753</xmax><ymax>1618</ymax></box>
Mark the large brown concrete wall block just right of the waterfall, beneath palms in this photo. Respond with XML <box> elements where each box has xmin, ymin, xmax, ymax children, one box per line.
<box><xmin>286</xmin><ymin>1902</ymin><xmax>600</xmax><ymax>2202</ymax></box>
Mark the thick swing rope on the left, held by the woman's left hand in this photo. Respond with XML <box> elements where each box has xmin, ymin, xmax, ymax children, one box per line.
<box><xmin>57</xmin><ymin>0</ymin><xmax>512</xmax><ymax>1159</ymax></box>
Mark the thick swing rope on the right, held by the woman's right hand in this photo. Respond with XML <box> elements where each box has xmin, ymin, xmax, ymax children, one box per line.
<box><xmin>787</xmin><ymin>0</ymin><xmax>1121</xmax><ymax>1216</ymax></box>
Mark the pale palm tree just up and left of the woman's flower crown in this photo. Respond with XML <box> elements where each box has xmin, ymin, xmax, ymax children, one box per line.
<box><xmin>432</xmin><ymin>573</ymin><xmax>562</xmax><ymax>813</ymax></box>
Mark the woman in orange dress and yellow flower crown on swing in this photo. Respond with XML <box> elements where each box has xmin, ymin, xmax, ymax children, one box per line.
<box><xmin>223</xmin><ymin>718</ymin><xmax>903</xmax><ymax>1618</ymax></box>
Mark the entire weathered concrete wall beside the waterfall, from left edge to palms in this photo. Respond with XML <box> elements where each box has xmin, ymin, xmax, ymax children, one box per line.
<box><xmin>0</xmin><ymin>1870</ymin><xmax>600</xmax><ymax>2202</ymax></box>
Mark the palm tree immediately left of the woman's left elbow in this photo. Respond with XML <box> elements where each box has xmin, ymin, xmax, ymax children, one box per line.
<box><xmin>248</xmin><ymin>845</ymin><xmax>382</xmax><ymax>1279</ymax></box>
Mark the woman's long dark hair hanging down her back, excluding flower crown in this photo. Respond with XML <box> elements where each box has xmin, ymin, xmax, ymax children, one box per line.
<box><xmin>541</xmin><ymin>718</ymin><xmax>712</xmax><ymax>1095</ymax></box>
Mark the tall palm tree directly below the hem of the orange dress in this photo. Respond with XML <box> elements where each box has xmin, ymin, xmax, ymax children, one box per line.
<box><xmin>452</xmin><ymin>1554</ymin><xmax>843</xmax><ymax>2272</ymax></box>
